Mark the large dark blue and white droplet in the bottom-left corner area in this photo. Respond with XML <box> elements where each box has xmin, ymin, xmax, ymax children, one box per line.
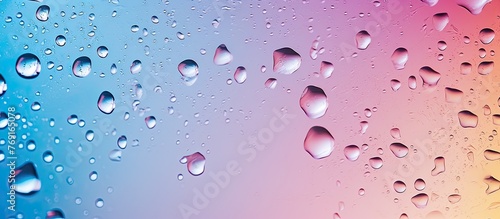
<box><xmin>14</xmin><ymin>162</ymin><xmax>42</xmax><ymax>195</ymax></box>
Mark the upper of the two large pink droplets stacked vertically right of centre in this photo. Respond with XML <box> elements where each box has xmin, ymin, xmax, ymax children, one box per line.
<box><xmin>299</xmin><ymin>85</ymin><xmax>328</xmax><ymax>119</ymax></box>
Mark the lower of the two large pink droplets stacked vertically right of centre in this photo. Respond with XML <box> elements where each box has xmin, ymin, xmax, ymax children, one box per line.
<box><xmin>304</xmin><ymin>126</ymin><xmax>335</xmax><ymax>159</ymax></box>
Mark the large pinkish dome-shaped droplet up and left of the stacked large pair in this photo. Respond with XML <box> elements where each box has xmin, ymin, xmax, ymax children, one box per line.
<box><xmin>273</xmin><ymin>47</ymin><xmax>302</xmax><ymax>75</ymax></box>
